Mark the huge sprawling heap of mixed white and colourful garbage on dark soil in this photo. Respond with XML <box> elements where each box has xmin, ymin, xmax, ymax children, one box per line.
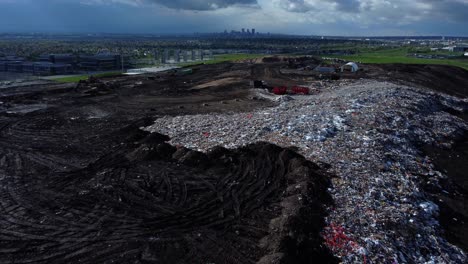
<box><xmin>145</xmin><ymin>80</ymin><xmax>468</xmax><ymax>263</ymax></box>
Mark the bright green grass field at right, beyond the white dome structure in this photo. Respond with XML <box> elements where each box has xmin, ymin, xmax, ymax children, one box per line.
<box><xmin>337</xmin><ymin>48</ymin><xmax>468</xmax><ymax>70</ymax></box>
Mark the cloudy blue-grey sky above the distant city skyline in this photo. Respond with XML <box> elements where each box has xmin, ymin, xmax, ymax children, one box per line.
<box><xmin>0</xmin><ymin>0</ymin><xmax>468</xmax><ymax>36</ymax></box>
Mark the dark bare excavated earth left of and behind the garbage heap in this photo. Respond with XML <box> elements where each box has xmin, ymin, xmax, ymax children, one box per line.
<box><xmin>0</xmin><ymin>60</ymin><xmax>468</xmax><ymax>263</ymax></box>
